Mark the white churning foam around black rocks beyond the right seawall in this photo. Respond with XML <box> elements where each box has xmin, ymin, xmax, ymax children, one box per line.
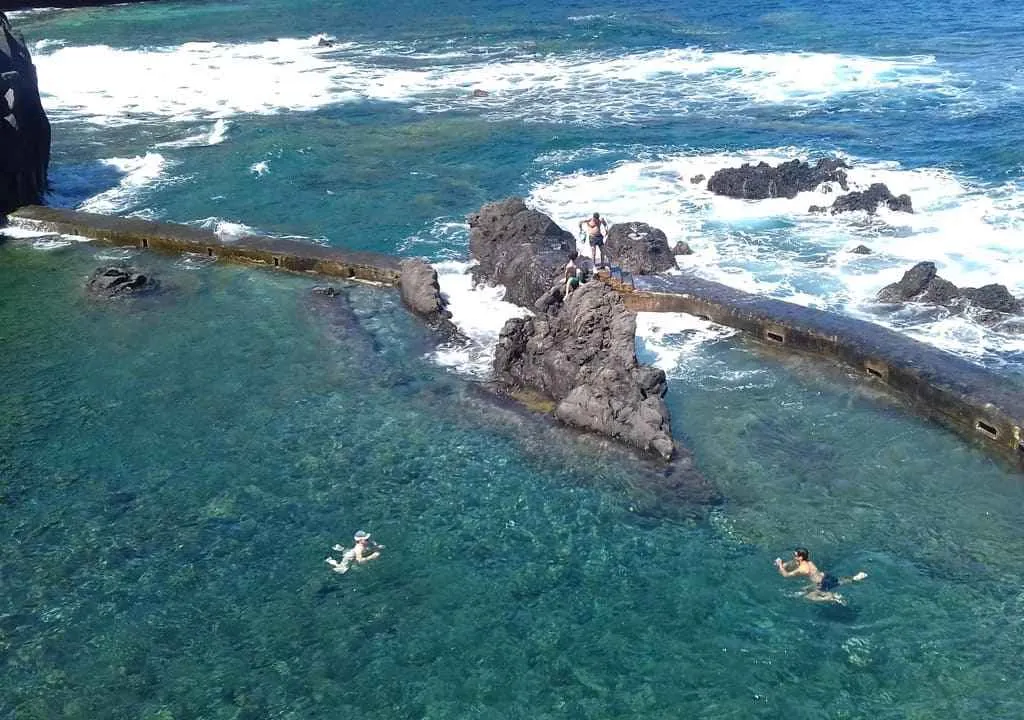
<box><xmin>528</xmin><ymin>147</ymin><xmax>1024</xmax><ymax>362</ymax></box>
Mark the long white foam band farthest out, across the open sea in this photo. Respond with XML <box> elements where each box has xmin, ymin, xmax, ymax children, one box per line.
<box><xmin>25</xmin><ymin>36</ymin><xmax>954</xmax><ymax>125</ymax></box>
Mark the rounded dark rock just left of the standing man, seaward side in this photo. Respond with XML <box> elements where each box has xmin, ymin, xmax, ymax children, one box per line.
<box><xmin>469</xmin><ymin>198</ymin><xmax>575</xmax><ymax>307</ymax></box>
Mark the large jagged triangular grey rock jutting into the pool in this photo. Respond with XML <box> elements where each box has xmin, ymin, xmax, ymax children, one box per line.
<box><xmin>495</xmin><ymin>283</ymin><xmax>675</xmax><ymax>460</ymax></box>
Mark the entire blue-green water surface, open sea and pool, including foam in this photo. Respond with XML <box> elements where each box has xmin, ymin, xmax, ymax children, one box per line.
<box><xmin>6</xmin><ymin>0</ymin><xmax>1024</xmax><ymax>720</ymax></box>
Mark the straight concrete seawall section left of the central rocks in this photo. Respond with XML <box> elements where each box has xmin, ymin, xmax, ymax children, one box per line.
<box><xmin>7</xmin><ymin>205</ymin><xmax>400</xmax><ymax>285</ymax></box>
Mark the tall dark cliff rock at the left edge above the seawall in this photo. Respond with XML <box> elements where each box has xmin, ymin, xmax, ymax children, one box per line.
<box><xmin>0</xmin><ymin>12</ymin><xmax>50</xmax><ymax>216</ymax></box>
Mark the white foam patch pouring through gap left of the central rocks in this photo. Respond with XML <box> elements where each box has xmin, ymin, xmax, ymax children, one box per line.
<box><xmin>432</xmin><ymin>261</ymin><xmax>529</xmax><ymax>379</ymax></box>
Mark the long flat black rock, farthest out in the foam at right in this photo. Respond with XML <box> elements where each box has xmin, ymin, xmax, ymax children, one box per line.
<box><xmin>708</xmin><ymin>158</ymin><xmax>850</xmax><ymax>200</ymax></box>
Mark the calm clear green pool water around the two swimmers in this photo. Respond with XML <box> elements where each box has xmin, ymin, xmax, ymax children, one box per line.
<box><xmin>0</xmin><ymin>244</ymin><xmax>1024</xmax><ymax>719</ymax></box>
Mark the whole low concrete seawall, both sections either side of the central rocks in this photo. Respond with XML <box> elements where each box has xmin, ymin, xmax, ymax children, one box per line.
<box><xmin>8</xmin><ymin>206</ymin><xmax>1024</xmax><ymax>471</ymax></box>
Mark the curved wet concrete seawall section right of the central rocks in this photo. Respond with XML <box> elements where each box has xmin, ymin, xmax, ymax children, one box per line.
<box><xmin>615</xmin><ymin>276</ymin><xmax>1024</xmax><ymax>470</ymax></box>
